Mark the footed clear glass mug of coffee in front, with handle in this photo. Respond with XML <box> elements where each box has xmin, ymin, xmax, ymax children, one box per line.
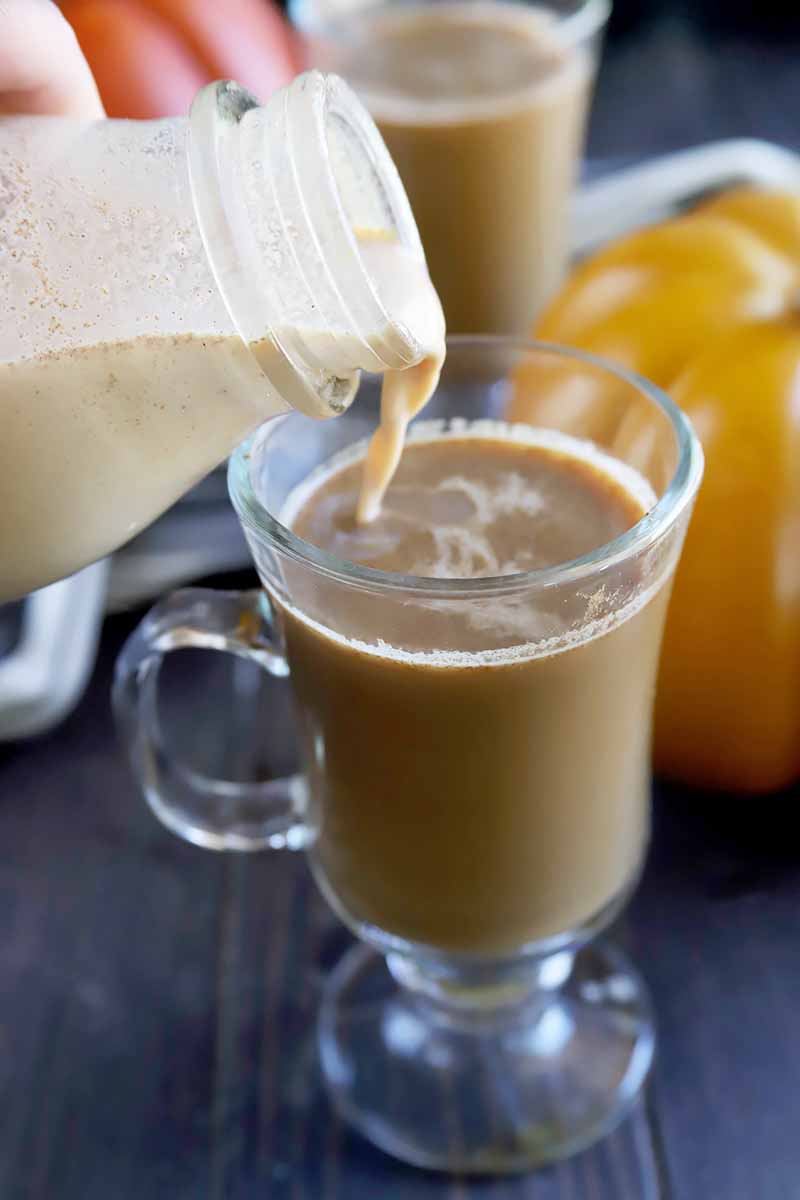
<box><xmin>114</xmin><ymin>337</ymin><xmax>703</xmax><ymax>1172</ymax></box>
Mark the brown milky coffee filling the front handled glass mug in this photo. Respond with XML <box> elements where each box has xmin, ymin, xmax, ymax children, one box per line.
<box><xmin>283</xmin><ymin>422</ymin><xmax>667</xmax><ymax>954</ymax></box>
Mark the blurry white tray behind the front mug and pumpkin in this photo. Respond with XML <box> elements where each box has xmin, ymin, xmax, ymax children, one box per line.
<box><xmin>0</xmin><ymin>139</ymin><xmax>800</xmax><ymax>742</ymax></box>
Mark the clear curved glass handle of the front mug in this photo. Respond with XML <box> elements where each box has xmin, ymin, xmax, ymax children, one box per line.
<box><xmin>113</xmin><ymin>588</ymin><xmax>308</xmax><ymax>851</ymax></box>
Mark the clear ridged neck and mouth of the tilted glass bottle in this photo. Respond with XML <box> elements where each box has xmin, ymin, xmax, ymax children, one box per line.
<box><xmin>188</xmin><ymin>71</ymin><xmax>425</xmax><ymax>416</ymax></box>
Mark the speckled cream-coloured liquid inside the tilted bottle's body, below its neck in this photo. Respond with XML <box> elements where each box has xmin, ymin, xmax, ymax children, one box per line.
<box><xmin>0</xmin><ymin>336</ymin><xmax>278</xmax><ymax>601</ymax></box>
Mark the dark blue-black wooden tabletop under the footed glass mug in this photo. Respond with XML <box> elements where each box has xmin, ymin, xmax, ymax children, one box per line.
<box><xmin>0</xmin><ymin>20</ymin><xmax>800</xmax><ymax>1200</ymax></box>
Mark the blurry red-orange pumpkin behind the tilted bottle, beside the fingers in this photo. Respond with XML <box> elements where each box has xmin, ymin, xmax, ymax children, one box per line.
<box><xmin>61</xmin><ymin>0</ymin><xmax>299</xmax><ymax>119</ymax></box>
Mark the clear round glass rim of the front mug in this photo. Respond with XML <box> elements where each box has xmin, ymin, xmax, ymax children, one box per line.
<box><xmin>228</xmin><ymin>334</ymin><xmax>703</xmax><ymax>599</ymax></box>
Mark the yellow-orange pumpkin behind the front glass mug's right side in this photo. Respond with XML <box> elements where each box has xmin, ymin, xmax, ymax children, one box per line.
<box><xmin>511</xmin><ymin>190</ymin><xmax>800</xmax><ymax>793</ymax></box>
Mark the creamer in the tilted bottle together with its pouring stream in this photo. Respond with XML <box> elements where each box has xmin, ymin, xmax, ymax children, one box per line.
<box><xmin>0</xmin><ymin>235</ymin><xmax>444</xmax><ymax>602</ymax></box>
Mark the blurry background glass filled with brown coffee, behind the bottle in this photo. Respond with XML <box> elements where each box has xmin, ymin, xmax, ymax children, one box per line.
<box><xmin>318</xmin><ymin>0</ymin><xmax>591</xmax><ymax>332</ymax></box>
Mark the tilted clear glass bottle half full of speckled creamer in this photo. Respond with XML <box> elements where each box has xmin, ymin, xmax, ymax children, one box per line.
<box><xmin>0</xmin><ymin>72</ymin><xmax>425</xmax><ymax>601</ymax></box>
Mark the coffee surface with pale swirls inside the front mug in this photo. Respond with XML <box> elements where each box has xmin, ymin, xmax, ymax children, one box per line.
<box><xmin>282</xmin><ymin>421</ymin><xmax>655</xmax><ymax>580</ymax></box>
